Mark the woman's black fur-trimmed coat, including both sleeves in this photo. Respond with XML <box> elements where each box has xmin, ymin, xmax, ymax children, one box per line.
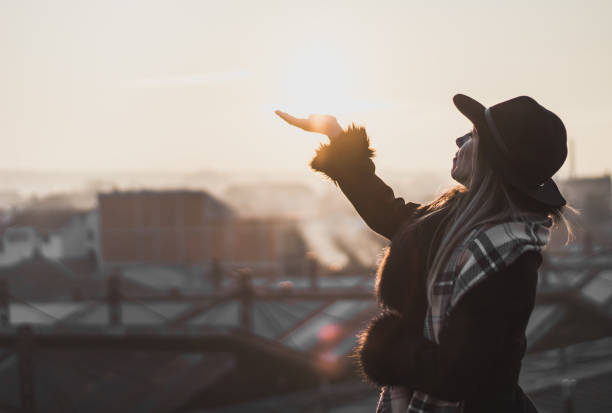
<box><xmin>311</xmin><ymin>126</ymin><xmax>542</xmax><ymax>413</ymax></box>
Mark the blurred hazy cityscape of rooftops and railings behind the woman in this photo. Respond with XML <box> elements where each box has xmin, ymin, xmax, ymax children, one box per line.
<box><xmin>0</xmin><ymin>171</ymin><xmax>612</xmax><ymax>413</ymax></box>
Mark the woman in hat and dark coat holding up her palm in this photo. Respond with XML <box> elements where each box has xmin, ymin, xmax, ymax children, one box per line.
<box><xmin>276</xmin><ymin>95</ymin><xmax>567</xmax><ymax>413</ymax></box>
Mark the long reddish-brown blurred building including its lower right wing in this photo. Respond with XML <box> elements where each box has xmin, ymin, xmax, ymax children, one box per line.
<box><xmin>98</xmin><ymin>190</ymin><xmax>306</xmax><ymax>273</ymax></box>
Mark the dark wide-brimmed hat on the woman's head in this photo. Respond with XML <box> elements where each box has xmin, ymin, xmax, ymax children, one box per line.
<box><xmin>453</xmin><ymin>94</ymin><xmax>567</xmax><ymax>208</ymax></box>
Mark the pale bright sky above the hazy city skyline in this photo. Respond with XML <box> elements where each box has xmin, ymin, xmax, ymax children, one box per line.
<box><xmin>0</xmin><ymin>0</ymin><xmax>612</xmax><ymax>174</ymax></box>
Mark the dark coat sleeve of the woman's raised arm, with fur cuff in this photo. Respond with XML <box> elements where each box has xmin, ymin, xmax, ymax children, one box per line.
<box><xmin>310</xmin><ymin>125</ymin><xmax>419</xmax><ymax>240</ymax></box>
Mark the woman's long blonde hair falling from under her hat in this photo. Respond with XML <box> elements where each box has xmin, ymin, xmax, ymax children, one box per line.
<box><xmin>415</xmin><ymin>130</ymin><xmax>576</xmax><ymax>303</ymax></box>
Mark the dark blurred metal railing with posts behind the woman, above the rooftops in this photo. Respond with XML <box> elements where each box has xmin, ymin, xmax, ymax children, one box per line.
<box><xmin>0</xmin><ymin>254</ymin><xmax>612</xmax><ymax>412</ymax></box>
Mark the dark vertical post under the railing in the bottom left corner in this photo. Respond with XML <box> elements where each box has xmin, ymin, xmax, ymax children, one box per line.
<box><xmin>17</xmin><ymin>324</ymin><xmax>36</xmax><ymax>413</ymax></box>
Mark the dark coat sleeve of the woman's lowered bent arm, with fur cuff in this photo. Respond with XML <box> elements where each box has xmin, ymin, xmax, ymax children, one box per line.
<box><xmin>359</xmin><ymin>251</ymin><xmax>541</xmax><ymax>401</ymax></box>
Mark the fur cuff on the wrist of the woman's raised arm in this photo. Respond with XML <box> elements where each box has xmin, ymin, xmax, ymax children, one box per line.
<box><xmin>310</xmin><ymin>124</ymin><xmax>375</xmax><ymax>181</ymax></box>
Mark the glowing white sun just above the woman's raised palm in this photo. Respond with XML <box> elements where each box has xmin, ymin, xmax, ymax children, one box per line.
<box><xmin>285</xmin><ymin>45</ymin><xmax>356</xmax><ymax>116</ymax></box>
